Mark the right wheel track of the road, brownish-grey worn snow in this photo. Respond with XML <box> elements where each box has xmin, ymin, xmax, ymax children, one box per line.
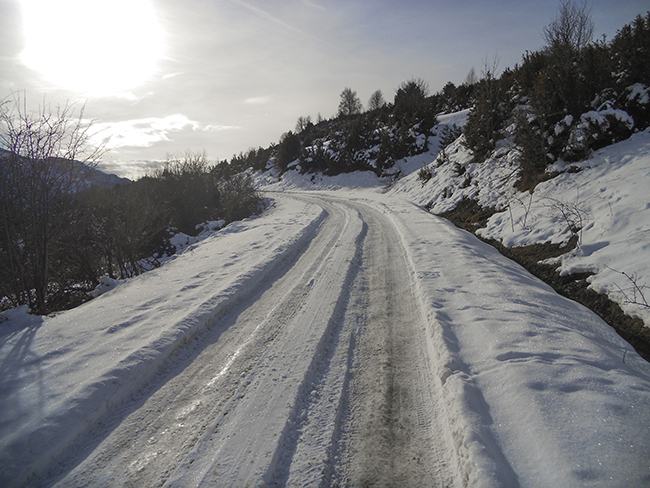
<box><xmin>326</xmin><ymin>198</ymin><xmax>453</xmax><ymax>487</ymax></box>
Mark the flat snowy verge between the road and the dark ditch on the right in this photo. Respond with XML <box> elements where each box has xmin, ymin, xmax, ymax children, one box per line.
<box><xmin>364</xmin><ymin>193</ymin><xmax>650</xmax><ymax>487</ymax></box>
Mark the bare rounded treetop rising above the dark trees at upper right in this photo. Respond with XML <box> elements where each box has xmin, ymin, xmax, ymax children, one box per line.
<box><xmin>543</xmin><ymin>0</ymin><xmax>594</xmax><ymax>52</ymax></box>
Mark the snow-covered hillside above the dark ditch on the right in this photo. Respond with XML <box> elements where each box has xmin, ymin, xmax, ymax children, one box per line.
<box><xmin>391</xmin><ymin>129</ymin><xmax>650</xmax><ymax>326</ymax></box>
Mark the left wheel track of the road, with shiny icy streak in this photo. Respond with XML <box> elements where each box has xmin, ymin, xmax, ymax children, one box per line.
<box><xmin>53</xmin><ymin>197</ymin><xmax>343</xmax><ymax>486</ymax></box>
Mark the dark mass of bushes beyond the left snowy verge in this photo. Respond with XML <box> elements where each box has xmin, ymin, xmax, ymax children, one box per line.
<box><xmin>0</xmin><ymin>151</ymin><xmax>261</xmax><ymax>313</ymax></box>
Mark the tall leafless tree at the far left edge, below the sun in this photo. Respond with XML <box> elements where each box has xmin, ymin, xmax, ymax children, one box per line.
<box><xmin>0</xmin><ymin>93</ymin><xmax>103</xmax><ymax>313</ymax></box>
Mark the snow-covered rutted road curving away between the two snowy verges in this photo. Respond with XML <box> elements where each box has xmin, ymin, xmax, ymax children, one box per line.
<box><xmin>56</xmin><ymin>194</ymin><xmax>458</xmax><ymax>487</ymax></box>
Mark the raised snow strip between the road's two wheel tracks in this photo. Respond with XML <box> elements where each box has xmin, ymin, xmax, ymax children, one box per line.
<box><xmin>161</xmin><ymin>196</ymin><xmax>365</xmax><ymax>487</ymax></box>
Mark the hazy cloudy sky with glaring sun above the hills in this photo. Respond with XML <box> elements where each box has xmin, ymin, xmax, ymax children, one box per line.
<box><xmin>0</xmin><ymin>0</ymin><xmax>650</xmax><ymax>177</ymax></box>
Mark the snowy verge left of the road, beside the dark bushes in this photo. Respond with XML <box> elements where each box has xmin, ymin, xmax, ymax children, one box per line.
<box><xmin>0</xmin><ymin>200</ymin><xmax>324</xmax><ymax>486</ymax></box>
